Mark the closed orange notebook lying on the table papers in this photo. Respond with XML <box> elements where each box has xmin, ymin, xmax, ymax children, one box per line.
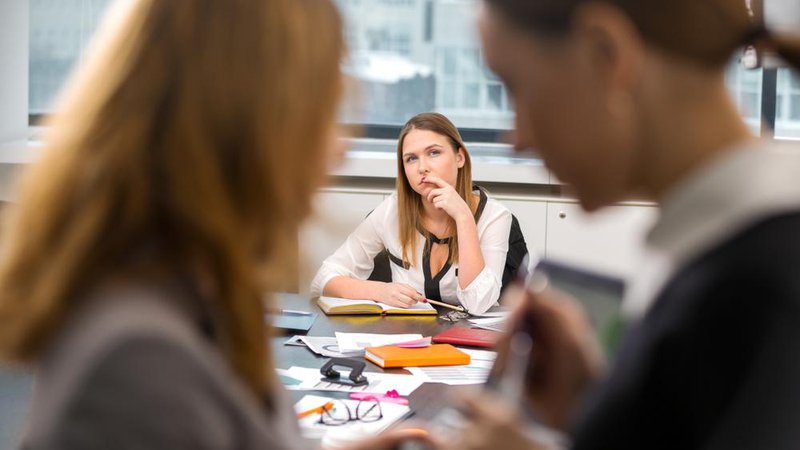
<box><xmin>364</xmin><ymin>344</ymin><xmax>470</xmax><ymax>368</ymax></box>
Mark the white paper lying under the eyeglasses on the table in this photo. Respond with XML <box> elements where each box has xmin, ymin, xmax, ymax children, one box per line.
<box><xmin>294</xmin><ymin>395</ymin><xmax>411</xmax><ymax>439</ymax></box>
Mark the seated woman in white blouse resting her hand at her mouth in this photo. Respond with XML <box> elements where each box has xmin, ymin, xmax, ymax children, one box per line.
<box><xmin>311</xmin><ymin>113</ymin><xmax>528</xmax><ymax>314</ymax></box>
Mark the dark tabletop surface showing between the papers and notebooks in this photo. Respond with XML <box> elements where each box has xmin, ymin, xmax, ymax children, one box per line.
<box><xmin>271</xmin><ymin>293</ymin><xmax>494</xmax><ymax>421</ymax></box>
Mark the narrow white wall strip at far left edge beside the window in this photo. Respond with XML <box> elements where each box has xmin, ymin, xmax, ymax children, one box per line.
<box><xmin>0</xmin><ymin>0</ymin><xmax>28</xmax><ymax>144</ymax></box>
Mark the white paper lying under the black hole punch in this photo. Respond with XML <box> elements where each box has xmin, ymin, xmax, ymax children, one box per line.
<box><xmin>279</xmin><ymin>366</ymin><xmax>425</xmax><ymax>396</ymax></box>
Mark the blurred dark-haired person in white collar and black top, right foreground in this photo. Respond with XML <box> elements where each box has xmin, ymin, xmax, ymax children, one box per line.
<box><xmin>434</xmin><ymin>0</ymin><xmax>800</xmax><ymax>450</ymax></box>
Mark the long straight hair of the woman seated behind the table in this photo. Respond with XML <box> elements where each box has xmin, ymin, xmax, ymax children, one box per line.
<box><xmin>395</xmin><ymin>113</ymin><xmax>478</xmax><ymax>267</ymax></box>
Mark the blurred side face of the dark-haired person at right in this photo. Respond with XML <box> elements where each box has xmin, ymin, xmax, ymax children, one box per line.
<box><xmin>480</xmin><ymin>6</ymin><xmax>636</xmax><ymax>210</ymax></box>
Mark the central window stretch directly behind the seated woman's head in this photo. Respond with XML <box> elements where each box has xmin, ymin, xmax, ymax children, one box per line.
<box><xmin>337</xmin><ymin>0</ymin><xmax>513</xmax><ymax>135</ymax></box>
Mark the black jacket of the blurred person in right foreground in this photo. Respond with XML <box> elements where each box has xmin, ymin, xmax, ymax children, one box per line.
<box><xmin>573</xmin><ymin>213</ymin><xmax>800</xmax><ymax>450</ymax></box>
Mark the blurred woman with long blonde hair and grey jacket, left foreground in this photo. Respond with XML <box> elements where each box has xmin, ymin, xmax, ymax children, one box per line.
<box><xmin>0</xmin><ymin>0</ymin><xmax>424</xmax><ymax>450</ymax></box>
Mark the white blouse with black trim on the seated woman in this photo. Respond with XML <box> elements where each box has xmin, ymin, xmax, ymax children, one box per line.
<box><xmin>311</xmin><ymin>190</ymin><xmax>511</xmax><ymax>314</ymax></box>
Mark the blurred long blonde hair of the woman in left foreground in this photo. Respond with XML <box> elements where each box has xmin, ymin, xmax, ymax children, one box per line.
<box><xmin>0</xmin><ymin>0</ymin><xmax>344</xmax><ymax>402</ymax></box>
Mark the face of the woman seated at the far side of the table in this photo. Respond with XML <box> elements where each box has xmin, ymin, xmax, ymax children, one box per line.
<box><xmin>402</xmin><ymin>129</ymin><xmax>464</xmax><ymax>198</ymax></box>
